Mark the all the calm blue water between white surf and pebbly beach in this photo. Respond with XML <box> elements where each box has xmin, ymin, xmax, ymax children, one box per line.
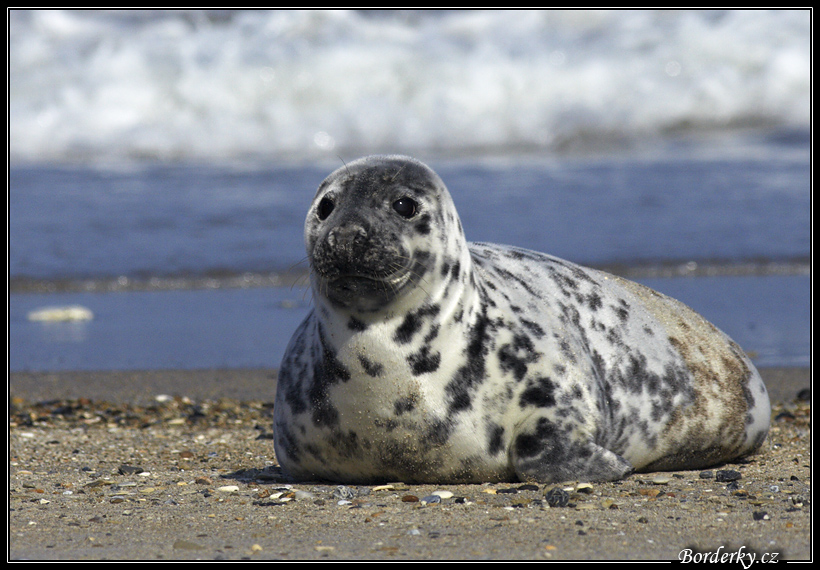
<box><xmin>9</xmin><ymin>141</ymin><xmax>811</xmax><ymax>370</ymax></box>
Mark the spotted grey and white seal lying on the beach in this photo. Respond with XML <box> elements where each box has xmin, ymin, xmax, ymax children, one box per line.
<box><xmin>274</xmin><ymin>156</ymin><xmax>771</xmax><ymax>483</ymax></box>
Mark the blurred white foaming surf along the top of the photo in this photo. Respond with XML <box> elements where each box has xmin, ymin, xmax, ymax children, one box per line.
<box><xmin>9</xmin><ymin>10</ymin><xmax>811</xmax><ymax>162</ymax></box>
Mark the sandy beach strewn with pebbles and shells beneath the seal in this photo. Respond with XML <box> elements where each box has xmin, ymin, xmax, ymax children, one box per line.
<box><xmin>9</xmin><ymin>368</ymin><xmax>812</xmax><ymax>562</ymax></box>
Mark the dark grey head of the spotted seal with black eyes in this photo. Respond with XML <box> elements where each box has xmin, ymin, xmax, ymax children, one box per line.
<box><xmin>305</xmin><ymin>157</ymin><xmax>464</xmax><ymax>313</ymax></box>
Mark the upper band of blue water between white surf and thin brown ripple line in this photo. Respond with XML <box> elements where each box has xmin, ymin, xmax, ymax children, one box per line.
<box><xmin>9</xmin><ymin>138</ymin><xmax>811</xmax><ymax>280</ymax></box>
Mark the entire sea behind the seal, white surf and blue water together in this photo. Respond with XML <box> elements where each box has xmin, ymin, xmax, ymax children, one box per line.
<box><xmin>8</xmin><ymin>10</ymin><xmax>811</xmax><ymax>371</ymax></box>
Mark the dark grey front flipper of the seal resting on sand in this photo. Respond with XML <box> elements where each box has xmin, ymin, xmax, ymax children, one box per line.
<box><xmin>511</xmin><ymin>418</ymin><xmax>633</xmax><ymax>483</ymax></box>
